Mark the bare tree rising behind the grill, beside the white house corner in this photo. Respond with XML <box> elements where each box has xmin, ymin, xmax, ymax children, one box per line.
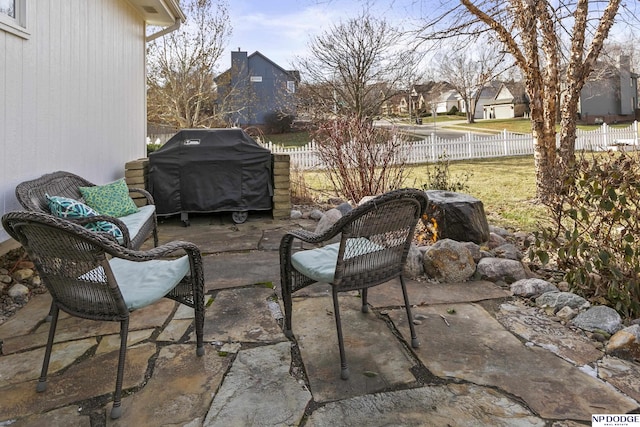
<box><xmin>147</xmin><ymin>0</ymin><xmax>231</xmax><ymax>128</ymax></box>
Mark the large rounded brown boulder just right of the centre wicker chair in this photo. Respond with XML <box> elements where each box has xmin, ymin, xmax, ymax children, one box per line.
<box><xmin>424</xmin><ymin>239</ymin><xmax>476</xmax><ymax>283</ymax></box>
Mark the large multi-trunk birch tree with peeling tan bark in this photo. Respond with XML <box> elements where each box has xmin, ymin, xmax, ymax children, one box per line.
<box><xmin>422</xmin><ymin>0</ymin><xmax>621</xmax><ymax>200</ymax></box>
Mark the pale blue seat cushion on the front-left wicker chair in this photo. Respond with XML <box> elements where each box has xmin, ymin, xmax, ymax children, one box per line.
<box><xmin>109</xmin><ymin>255</ymin><xmax>189</xmax><ymax>310</ymax></box>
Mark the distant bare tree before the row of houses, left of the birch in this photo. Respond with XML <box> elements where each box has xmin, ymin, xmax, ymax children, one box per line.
<box><xmin>438</xmin><ymin>42</ymin><xmax>508</xmax><ymax>123</ymax></box>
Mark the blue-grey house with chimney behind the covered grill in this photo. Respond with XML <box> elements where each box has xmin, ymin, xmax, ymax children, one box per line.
<box><xmin>215</xmin><ymin>49</ymin><xmax>300</xmax><ymax>126</ymax></box>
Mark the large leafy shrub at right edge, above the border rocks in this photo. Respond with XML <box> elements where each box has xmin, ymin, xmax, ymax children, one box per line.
<box><xmin>529</xmin><ymin>152</ymin><xmax>640</xmax><ymax>318</ymax></box>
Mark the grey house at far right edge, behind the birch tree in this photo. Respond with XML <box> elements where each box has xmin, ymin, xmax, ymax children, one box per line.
<box><xmin>578</xmin><ymin>56</ymin><xmax>638</xmax><ymax>123</ymax></box>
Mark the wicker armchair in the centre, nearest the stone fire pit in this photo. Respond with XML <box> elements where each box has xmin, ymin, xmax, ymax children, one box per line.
<box><xmin>280</xmin><ymin>189</ymin><xmax>427</xmax><ymax>380</ymax></box>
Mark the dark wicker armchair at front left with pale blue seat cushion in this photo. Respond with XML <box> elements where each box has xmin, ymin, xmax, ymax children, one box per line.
<box><xmin>2</xmin><ymin>211</ymin><xmax>204</xmax><ymax>419</ymax></box>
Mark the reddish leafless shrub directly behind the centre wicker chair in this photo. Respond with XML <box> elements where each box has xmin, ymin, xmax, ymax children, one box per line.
<box><xmin>311</xmin><ymin>116</ymin><xmax>408</xmax><ymax>202</ymax></box>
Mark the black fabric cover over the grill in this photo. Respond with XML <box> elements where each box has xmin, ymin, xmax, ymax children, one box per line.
<box><xmin>149</xmin><ymin>129</ymin><xmax>273</xmax><ymax>215</ymax></box>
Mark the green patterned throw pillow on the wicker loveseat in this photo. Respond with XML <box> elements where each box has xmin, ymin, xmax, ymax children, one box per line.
<box><xmin>78</xmin><ymin>178</ymin><xmax>138</xmax><ymax>217</ymax></box>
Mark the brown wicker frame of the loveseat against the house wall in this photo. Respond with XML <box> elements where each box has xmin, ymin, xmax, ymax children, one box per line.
<box><xmin>16</xmin><ymin>171</ymin><xmax>158</xmax><ymax>249</ymax></box>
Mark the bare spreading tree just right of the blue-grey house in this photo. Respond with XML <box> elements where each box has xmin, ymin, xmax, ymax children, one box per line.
<box><xmin>295</xmin><ymin>12</ymin><xmax>421</xmax><ymax>118</ymax></box>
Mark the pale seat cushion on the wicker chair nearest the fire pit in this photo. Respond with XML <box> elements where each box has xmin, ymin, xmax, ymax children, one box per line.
<box><xmin>291</xmin><ymin>237</ymin><xmax>385</xmax><ymax>283</ymax></box>
